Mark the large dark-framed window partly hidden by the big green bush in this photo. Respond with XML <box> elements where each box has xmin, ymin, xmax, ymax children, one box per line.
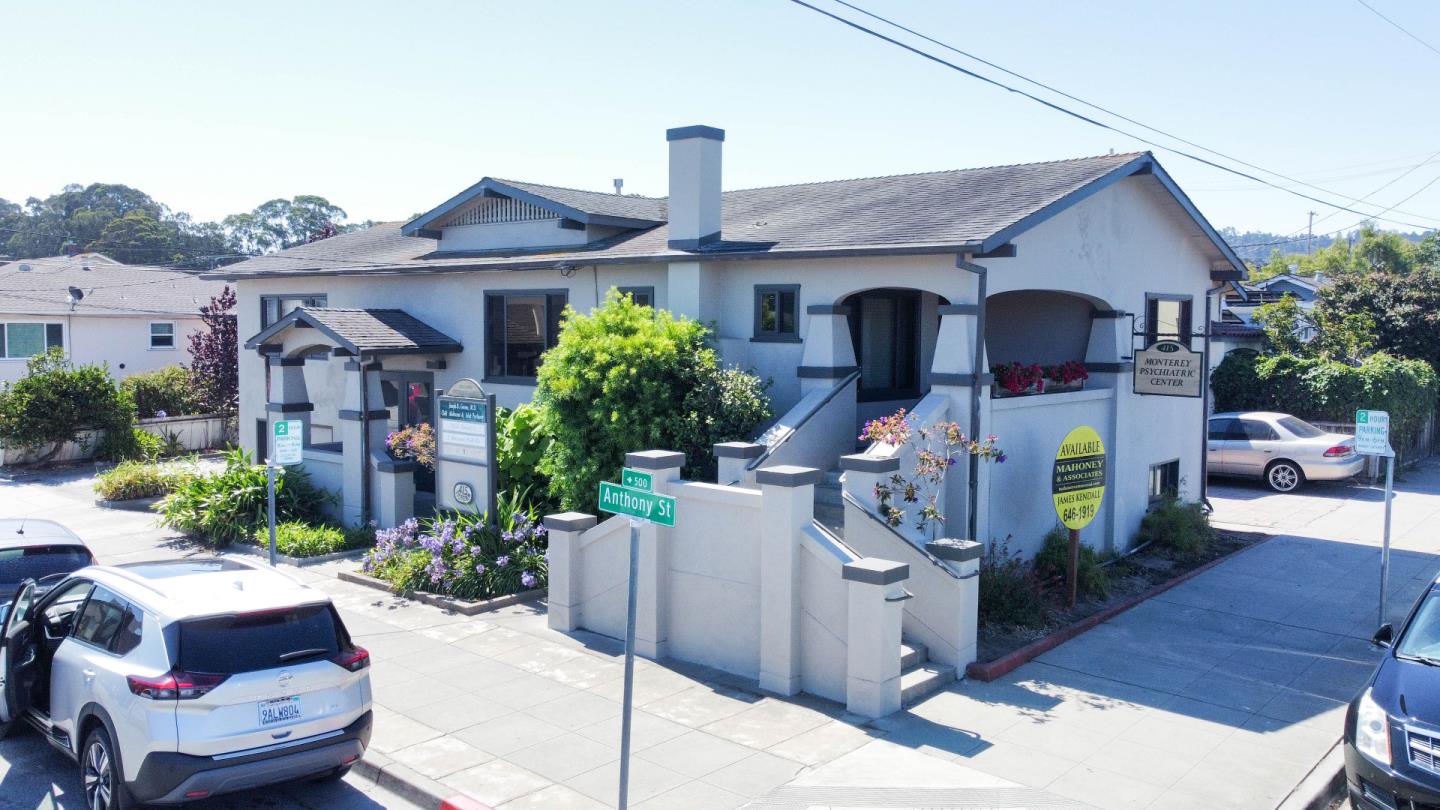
<box><xmin>485</xmin><ymin>290</ymin><xmax>569</xmax><ymax>385</ymax></box>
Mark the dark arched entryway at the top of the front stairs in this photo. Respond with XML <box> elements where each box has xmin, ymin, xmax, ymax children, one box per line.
<box><xmin>841</xmin><ymin>287</ymin><xmax>949</xmax><ymax>422</ymax></box>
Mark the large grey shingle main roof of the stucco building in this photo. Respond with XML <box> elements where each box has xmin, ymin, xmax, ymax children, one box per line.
<box><xmin>213</xmin><ymin>153</ymin><xmax>1238</xmax><ymax>278</ymax></box>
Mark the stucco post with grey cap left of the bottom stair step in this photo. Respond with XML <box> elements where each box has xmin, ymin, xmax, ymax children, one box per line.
<box><xmin>842</xmin><ymin>556</ymin><xmax>910</xmax><ymax>718</ymax></box>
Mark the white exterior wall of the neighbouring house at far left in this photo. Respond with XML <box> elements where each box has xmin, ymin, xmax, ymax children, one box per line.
<box><xmin>0</xmin><ymin>314</ymin><xmax>205</xmax><ymax>382</ymax></box>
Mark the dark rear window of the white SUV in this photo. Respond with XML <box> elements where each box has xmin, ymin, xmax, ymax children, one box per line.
<box><xmin>176</xmin><ymin>605</ymin><xmax>341</xmax><ymax>675</ymax></box>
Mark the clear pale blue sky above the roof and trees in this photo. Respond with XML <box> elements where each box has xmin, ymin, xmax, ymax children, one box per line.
<box><xmin>0</xmin><ymin>0</ymin><xmax>1440</xmax><ymax>239</ymax></box>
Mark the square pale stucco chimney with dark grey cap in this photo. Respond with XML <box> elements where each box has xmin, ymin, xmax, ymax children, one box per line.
<box><xmin>665</xmin><ymin>127</ymin><xmax>724</xmax><ymax>251</ymax></box>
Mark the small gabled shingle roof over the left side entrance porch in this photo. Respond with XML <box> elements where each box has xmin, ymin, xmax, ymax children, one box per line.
<box><xmin>245</xmin><ymin>307</ymin><xmax>462</xmax><ymax>355</ymax></box>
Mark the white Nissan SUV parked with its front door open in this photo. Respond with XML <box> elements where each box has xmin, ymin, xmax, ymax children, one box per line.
<box><xmin>0</xmin><ymin>559</ymin><xmax>372</xmax><ymax>810</ymax></box>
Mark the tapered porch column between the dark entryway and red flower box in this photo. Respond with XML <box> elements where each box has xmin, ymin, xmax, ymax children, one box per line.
<box><xmin>930</xmin><ymin>304</ymin><xmax>995</xmax><ymax>542</ymax></box>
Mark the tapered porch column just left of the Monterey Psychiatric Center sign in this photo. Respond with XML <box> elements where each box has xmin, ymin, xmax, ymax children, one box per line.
<box><xmin>1084</xmin><ymin>310</ymin><xmax>1138</xmax><ymax>551</ymax></box>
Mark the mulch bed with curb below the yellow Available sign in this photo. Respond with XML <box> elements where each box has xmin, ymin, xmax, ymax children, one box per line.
<box><xmin>965</xmin><ymin>530</ymin><xmax>1270</xmax><ymax>680</ymax></box>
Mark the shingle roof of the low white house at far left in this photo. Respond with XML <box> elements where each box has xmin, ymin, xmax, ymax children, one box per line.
<box><xmin>0</xmin><ymin>254</ymin><xmax>225</xmax><ymax>317</ymax></box>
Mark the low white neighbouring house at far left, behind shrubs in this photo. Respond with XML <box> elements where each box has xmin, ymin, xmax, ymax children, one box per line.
<box><xmin>0</xmin><ymin>254</ymin><xmax>225</xmax><ymax>382</ymax></box>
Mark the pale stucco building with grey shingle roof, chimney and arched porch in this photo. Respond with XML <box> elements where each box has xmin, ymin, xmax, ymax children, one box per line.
<box><xmin>207</xmin><ymin>127</ymin><xmax>1244</xmax><ymax>552</ymax></box>
